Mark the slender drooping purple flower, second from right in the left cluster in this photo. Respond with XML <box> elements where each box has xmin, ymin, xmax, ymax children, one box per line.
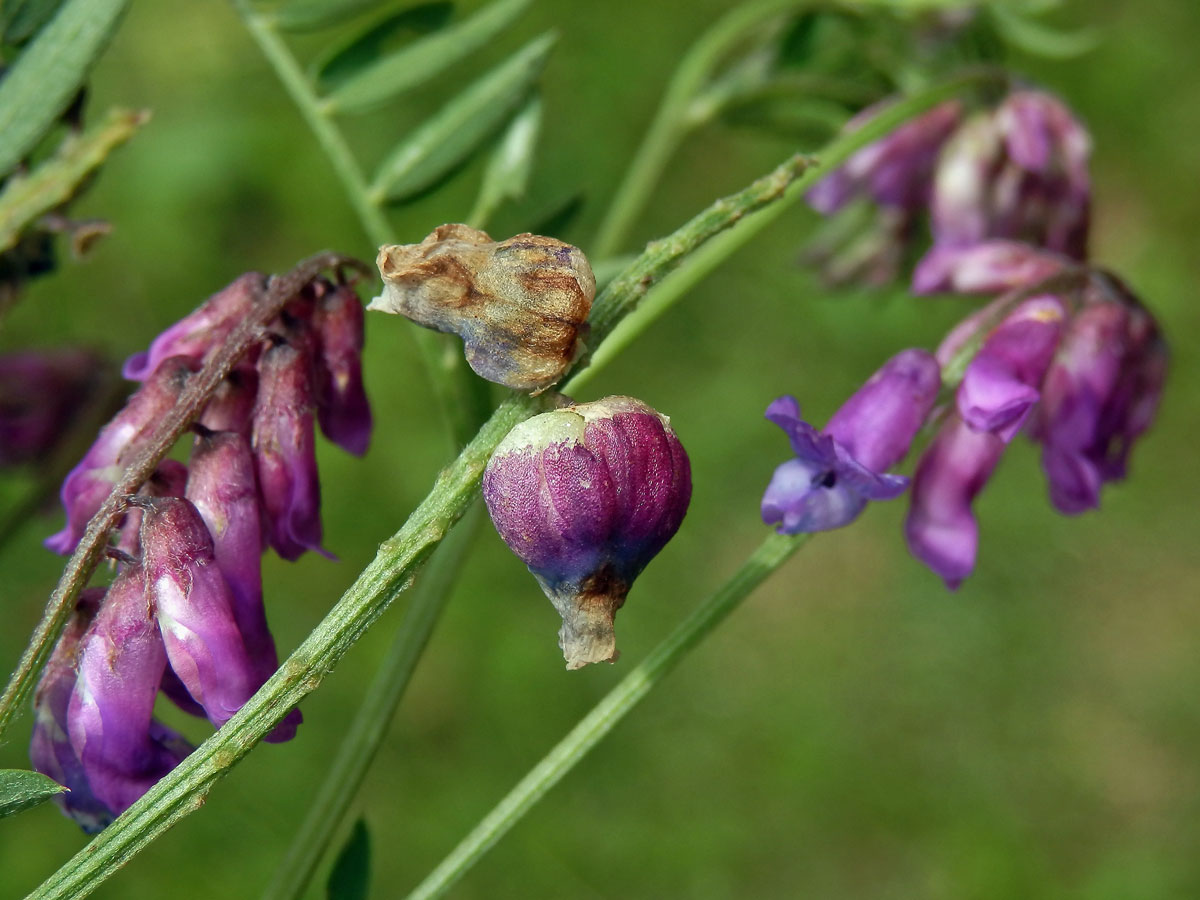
<box><xmin>253</xmin><ymin>342</ymin><xmax>329</xmax><ymax>559</ymax></box>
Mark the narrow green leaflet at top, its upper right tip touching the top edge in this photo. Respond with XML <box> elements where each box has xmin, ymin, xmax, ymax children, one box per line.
<box><xmin>326</xmin><ymin>0</ymin><xmax>529</xmax><ymax>113</ymax></box>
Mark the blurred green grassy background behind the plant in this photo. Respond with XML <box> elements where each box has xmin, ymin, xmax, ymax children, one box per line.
<box><xmin>0</xmin><ymin>0</ymin><xmax>1200</xmax><ymax>900</ymax></box>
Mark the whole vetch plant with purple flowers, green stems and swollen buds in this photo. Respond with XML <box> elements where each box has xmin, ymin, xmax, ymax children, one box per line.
<box><xmin>0</xmin><ymin>0</ymin><xmax>1166</xmax><ymax>898</ymax></box>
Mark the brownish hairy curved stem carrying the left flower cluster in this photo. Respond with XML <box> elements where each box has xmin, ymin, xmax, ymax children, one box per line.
<box><xmin>0</xmin><ymin>253</ymin><xmax>360</xmax><ymax>737</ymax></box>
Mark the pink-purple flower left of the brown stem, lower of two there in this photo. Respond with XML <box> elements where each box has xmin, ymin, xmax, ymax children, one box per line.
<box><xmin>46</xmin><ymin>356</ymin><xmax>196</xmax><ymax>553</ymax></box>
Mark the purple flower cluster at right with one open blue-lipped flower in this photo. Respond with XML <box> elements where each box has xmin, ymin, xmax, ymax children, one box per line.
<box><xmin>762</xmin><ymin>84</ymin><xmax>1166</xmax><ymax>589</ymax></box>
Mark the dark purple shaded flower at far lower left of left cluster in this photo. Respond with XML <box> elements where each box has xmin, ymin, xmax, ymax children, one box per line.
<box><xmin>29</xmin><ymin>588</ymin><xmax>114</xmax><ymax>834</ymax></box>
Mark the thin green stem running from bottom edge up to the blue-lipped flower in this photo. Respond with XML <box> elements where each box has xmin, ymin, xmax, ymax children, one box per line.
<box><xmin>408</xmin><ymin>534</ymin><xmax>811</xmax><ymax>900</ymax></box>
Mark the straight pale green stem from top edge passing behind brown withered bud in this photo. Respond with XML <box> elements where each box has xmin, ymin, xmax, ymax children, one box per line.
<box><xmin>234</xmin><ymin>0</ymin><xmax>491</xmax><ymax>448</ymax></box>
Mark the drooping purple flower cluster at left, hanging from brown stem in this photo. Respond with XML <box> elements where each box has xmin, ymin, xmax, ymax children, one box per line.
<box><xmin>30</xmin><ymin>274</ymin><xmax>371</xmax><ymax>830</ymax></box>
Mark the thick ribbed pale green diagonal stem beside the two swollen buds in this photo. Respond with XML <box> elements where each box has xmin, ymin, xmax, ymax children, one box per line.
<box><xmin>30</xmin><ymin>128</ymin><xmax>816</xmax><ymax>900</ymax></box>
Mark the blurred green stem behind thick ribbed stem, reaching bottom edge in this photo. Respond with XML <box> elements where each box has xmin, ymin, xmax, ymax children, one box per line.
<box><xmin>263</xmin><ymin>504</ymin><xmax>482</xmax><ymax>900</ymax></box>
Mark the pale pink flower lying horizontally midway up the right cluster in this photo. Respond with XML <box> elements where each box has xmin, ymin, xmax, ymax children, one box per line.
<box><xmin>912</xmin><ymin>240</ymin><xmax>1073</xmax><ymax>294</ymax></box>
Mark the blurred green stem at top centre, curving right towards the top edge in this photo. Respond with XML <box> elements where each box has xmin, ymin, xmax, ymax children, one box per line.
<box><xmin>590</xmin><ymin>0</ymin><xmax>811</xmax><ymax>258</ymax></box>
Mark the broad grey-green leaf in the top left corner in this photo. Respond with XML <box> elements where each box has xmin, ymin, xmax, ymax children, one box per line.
<box><xmin>0</xmin><ymin>0</ymin><xmax>128</xmax><ymax>181</ymax></box>
